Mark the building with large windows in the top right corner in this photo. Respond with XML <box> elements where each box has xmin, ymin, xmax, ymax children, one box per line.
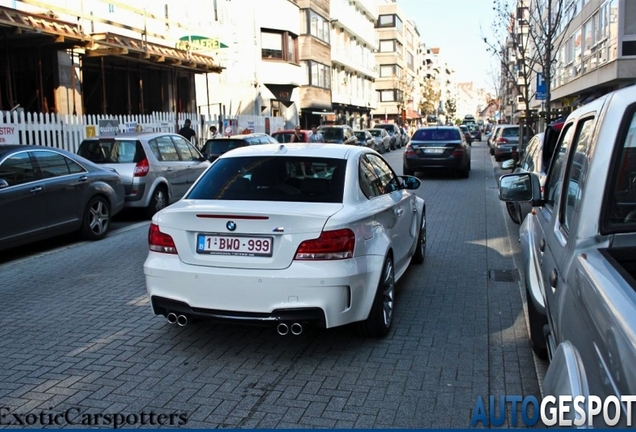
<box><xmin>551</xmin><ymin>0</ymin><xmax>636</xmax><ymax>109</ymax></box>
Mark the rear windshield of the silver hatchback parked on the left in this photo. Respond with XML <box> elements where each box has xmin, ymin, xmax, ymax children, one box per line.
<box><xmin>77</xmin><ymin>139</ymin><xmax>146</xmax><ymax>163</ymax></box>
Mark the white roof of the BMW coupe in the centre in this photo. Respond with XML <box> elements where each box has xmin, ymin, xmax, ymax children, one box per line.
<box><xmin>221</xmin><ymin>143</ymin><xmax>369</xmax><ymax>159</ymax></box>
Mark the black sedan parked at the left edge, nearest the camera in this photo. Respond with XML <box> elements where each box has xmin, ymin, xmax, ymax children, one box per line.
<box><xmin>0</xmin><ymin>144</ymin><xmax>124</xmax><ymax>250</ymax></box>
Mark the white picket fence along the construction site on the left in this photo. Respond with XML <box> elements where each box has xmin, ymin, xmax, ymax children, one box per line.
<box><xmin>0</xmin><ymin>111</ymin><xmax>284</xmax><ymax>153</ymax></box>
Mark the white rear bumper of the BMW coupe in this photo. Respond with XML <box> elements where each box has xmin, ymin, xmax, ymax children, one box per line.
<box><xmin>144</xmin><ymin>252</ymin><xmax>384</xmax><ymax>328</ymax></box>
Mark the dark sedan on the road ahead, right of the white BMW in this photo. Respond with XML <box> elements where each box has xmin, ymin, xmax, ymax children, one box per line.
<box><xmin>402</xmin><ymin>126</ymin><xmax>471</xmax><ymax>178</ymax></box>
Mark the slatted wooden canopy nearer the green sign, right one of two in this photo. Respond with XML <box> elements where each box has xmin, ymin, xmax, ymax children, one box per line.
<box><xmin>86</xmin><ymin>33</ymin><xmax>223</xmax><ymax>73</ymax></box>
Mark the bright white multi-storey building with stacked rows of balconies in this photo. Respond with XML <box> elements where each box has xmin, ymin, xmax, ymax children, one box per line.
<box><xmin>330</xmin><ymin>0</ymin><xmax>378</xmax><ymax>128</ymax></box>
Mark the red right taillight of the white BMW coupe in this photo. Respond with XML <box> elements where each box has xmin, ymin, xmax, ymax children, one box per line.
<box><xmin>294</xmin><ymin>229</ymin><xmax>356</xmax><ymax>261</ymax></box>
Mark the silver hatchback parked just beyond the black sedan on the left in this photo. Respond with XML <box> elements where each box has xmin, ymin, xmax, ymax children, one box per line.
<box><xmin>77</xmin><ymin>132</ymin><xmax>210</xmax><ymax>217</ymax></box>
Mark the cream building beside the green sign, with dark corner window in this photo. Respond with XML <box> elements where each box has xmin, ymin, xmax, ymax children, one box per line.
<box><xmin>196</xmin><ymin>0</ymin><xmax>308</xmax><ymax>128</ymax></box>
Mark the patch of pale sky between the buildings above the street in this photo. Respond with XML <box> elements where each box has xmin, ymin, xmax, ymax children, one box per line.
<box><xmin>397</xmin><ymin>0</ymin><xmax>497</xmax><ymax>90</ymax></box>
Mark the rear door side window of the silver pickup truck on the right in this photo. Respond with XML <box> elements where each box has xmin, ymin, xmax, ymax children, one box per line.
<box><xmin>560</xmin><ymin>117</ymin><xmax>594</xmax><ymax>233</ymax></box>
